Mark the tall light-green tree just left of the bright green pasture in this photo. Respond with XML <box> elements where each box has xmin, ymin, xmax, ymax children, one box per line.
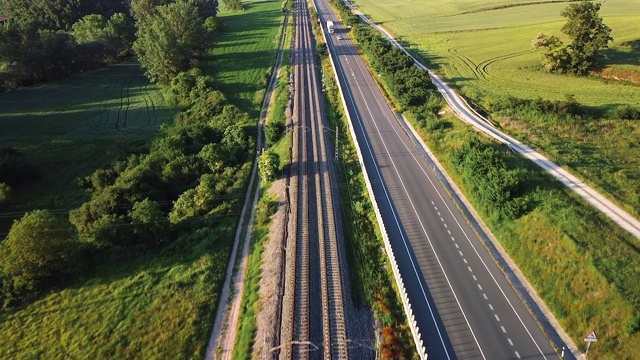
<box><xmin>133</xmin><ymin>2</ymin><xmax>205</xmax><ymax>84</ymax></box>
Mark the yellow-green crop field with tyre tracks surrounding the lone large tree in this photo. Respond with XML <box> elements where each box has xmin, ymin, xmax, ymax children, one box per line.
<box><xmin>356</xmin><ymin>0</ymin><xmax>640</xmax><ymax>109</ymax></box>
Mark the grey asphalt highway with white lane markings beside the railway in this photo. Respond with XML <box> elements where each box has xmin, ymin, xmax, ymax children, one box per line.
<box><xmin>316</xmin><ymin>0</ymin><xmax>558</xmax><ymax>359</ymax></box>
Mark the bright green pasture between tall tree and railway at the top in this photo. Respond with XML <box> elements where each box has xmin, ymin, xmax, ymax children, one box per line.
<box><xmin>204</xmin><ymin>0</ymin><xmax>282</xmax><ymax>116</ymax></box>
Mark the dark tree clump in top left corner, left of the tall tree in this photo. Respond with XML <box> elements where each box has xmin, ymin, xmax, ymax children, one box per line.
<box><xmin>0</xmin><ymin>0</ymin><xmax>134</xmax><ymax>90</ymax></box>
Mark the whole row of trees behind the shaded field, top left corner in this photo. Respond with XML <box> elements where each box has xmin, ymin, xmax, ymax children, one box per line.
<box><xmin>0</xmin><ymin>0</ymin><xmax>220</xmax><ymax>90</ymax></box>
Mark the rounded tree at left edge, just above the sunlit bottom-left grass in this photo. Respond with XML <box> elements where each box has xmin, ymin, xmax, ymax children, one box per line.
<box><xmin>0</xmin><ymin>210</ymin><xmax>79</xmax><ymax>294</ymax></box>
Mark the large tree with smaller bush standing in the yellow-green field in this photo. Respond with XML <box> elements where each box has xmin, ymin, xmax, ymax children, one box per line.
<box><xmin>533</xmin><ymin>0</ymin><xmax>613</xmax><ymax>75</ymax></box>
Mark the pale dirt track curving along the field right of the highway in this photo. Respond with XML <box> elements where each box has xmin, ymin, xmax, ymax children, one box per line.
<box><xmin>344</xmin><ymin>1</ymin><xmax>640</xmax><ymax>239</ymax></box>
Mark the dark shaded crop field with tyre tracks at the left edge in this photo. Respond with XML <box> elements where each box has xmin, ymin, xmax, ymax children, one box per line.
<box><xmin>0</xmin><ymin>63</ymin><xmax>172</xmax><ymax>141</ymax></box>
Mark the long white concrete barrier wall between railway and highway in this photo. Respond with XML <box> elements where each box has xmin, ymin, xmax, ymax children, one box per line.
<box><xmin>313</xmin><ymin>0</ymin><xmax>427</xmax><ymax>360</ymax></box>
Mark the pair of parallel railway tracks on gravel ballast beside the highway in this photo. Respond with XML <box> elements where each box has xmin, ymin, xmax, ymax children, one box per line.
<box><xmin>278</xmin><ymin>0</ymin><xmax>348</xmax><ymax>359</ymax></box>
